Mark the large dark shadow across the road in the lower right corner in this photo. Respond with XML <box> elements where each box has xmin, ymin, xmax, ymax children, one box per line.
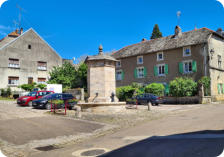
<box><xmin>100</xmin><ymin>130</ymin><xmax>224</xmax><ymax>157</ymax></box>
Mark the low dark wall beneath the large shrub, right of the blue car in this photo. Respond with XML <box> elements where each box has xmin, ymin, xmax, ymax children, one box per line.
<box><xmin>163</xmin><ymin>96</ymin><xmax>200</xmax><ymax>104</ymax></box>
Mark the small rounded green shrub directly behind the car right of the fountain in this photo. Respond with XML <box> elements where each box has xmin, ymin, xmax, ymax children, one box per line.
<box><xmin>145</xmin><ymin>83</ymin><xmax>165</xmax><ymax>96</ymax></box>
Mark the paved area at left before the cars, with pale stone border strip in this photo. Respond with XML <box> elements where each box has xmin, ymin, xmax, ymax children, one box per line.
<box><xmin>0</xmin><ymin>101</ymin><xmax>104</xmax><ymax>147</ymax></box>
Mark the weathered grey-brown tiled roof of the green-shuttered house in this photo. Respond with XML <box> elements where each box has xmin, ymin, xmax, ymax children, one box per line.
<box><xmin>112</xmin><ymin>28</ymin><xmax>214</xmax><ymax>59</ymax></box>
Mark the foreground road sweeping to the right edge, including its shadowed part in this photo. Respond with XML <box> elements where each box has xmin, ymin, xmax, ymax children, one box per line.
<box><xmin>30</xmin><ymin>104</ymin><xmax>224</xmax><ymax>157</ymax></box>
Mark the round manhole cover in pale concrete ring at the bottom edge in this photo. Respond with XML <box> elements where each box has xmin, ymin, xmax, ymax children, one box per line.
<box><xmin>72</xmin><ymin>148</ymin><xmax>109</xmax><ymax>157</ymax></box>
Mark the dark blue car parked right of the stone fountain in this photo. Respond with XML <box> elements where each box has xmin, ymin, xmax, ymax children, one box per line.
<box><xmin>136</xmin><ymin>93</ymin><xmax>163</xmax><ymax>106</ymax></box>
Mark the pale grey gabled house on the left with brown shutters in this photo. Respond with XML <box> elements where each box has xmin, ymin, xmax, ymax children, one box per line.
<box><xmin>0</xmin><ymin>28</ymin><xmax>63</xmax><ymax>91</ymax></box>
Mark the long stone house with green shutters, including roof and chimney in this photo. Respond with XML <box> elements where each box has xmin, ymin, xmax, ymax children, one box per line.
<box><xmin>112</xmin><ymin>26</ymin><xmax>224</xmax><ymax>99</ymax></box>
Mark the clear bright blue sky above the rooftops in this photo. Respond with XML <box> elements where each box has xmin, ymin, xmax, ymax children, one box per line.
<box><xmin>0</xmin><ymin>0</ymin><xmax>224</xmax><ymax>59</ymax></box>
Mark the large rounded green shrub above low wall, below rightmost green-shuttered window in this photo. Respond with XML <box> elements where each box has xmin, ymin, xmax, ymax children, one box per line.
<box><xmin>170</xmin><ymin>77</ymin><xmax>197</xmax><ymax>97</ymax></box>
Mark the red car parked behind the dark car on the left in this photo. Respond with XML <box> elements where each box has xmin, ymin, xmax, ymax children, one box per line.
<box><xmin>17</xmin><ymin>91</ymin><xmax>54</xmax><ymax>106</ymax></box>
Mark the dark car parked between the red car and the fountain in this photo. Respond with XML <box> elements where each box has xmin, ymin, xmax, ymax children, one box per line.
<box><xmin>32</xmin><ymin>93</ymin><xmax>76</xmax><ymax>110</ymax></box>
